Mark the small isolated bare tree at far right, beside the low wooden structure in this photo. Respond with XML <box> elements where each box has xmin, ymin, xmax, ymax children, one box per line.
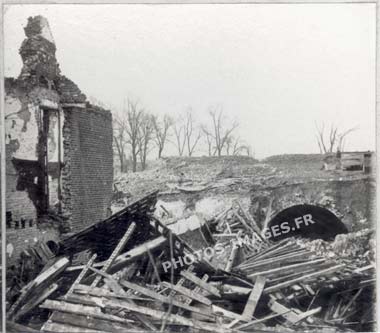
<box><xmin>316</xmin><ymin>124</ymin><xmax>357</xmax><ymax>154</ymax></box>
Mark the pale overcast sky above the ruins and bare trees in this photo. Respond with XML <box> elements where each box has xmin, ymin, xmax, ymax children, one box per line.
<box><xmin>4</xmin><ymin>4</ymin><xmax>376</xmax><ymax>158</ymax></box>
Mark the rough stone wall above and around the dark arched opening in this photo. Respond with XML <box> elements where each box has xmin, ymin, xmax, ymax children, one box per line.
<box><xmin>250</xmin><ymin>177</ymin><xmax>376</xmax><ymax>231</ymax></box>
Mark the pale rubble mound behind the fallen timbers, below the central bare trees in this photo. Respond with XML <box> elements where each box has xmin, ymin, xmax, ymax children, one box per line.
<box><xmin>114</xmin><ymin>156</ymin><xmax>276</xmax><ymax>207</ymax></box>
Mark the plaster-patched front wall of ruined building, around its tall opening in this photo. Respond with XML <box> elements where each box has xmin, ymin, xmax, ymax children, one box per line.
<box><xmin>4</xmin><ymin>79</ymin><xmax>59</xmax><ymax>265</ymax></box>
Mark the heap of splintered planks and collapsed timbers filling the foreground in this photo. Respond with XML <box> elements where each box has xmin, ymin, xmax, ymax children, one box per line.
<box><xmin>8</xmin><ymin>192</ymin><xmax>375</xmax><ymax>332</ymax></box>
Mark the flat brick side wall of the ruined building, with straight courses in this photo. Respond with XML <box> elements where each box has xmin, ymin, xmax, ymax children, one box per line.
<box><xmin>62</xmin><ymin>105</ymin><xmax>113</xmax><ymax>231</ymax></box>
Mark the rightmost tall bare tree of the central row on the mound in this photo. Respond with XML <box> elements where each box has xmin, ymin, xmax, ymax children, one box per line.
<box><xmin>203</xmin><ymin>109</ymin><xmax>238</xmax><ymax>156</ymax></box>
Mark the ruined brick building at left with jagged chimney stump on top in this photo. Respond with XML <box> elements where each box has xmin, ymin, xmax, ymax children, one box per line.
<box><xmin>5</xmin><ymin>16</ymin><xmax>113</xmax><ymax>266</ymax></box>
